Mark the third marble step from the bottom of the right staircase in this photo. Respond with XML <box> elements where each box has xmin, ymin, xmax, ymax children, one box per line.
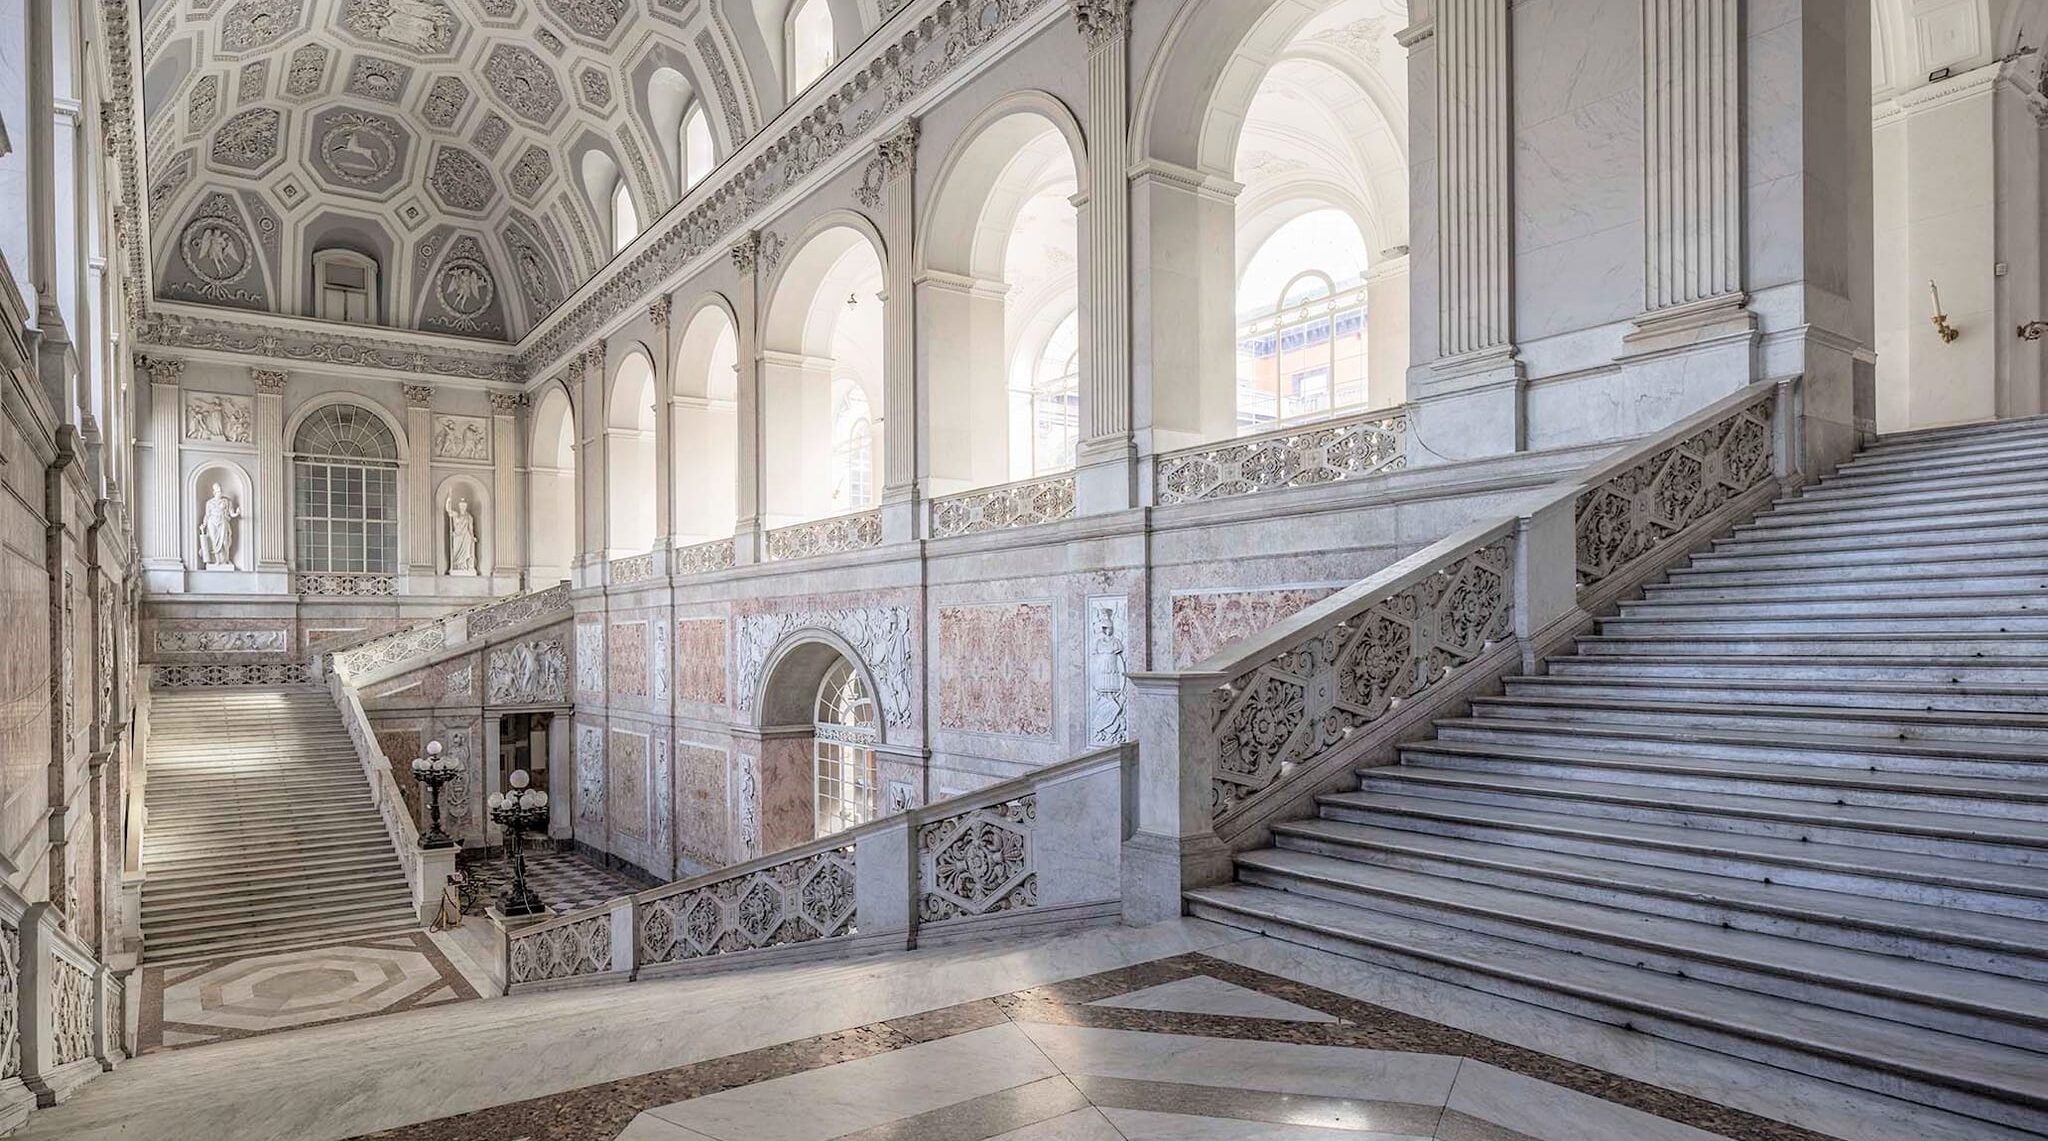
<box><xmin>1274</xmin><ymin>817</ymin><xmax>2048</xmax><ymax>981</ymax></box>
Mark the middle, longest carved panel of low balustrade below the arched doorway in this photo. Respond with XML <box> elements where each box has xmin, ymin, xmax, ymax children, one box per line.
<box><xmin>639</xmin><ymin>844</ymin><xmax>860</xmax><ymax>965</ymax></box>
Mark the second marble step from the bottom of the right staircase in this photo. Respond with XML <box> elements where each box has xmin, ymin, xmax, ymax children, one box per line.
<box><xmin>1237</xmin><ymin>850</ymin><xmax>2048</xmax><ymax>1047</ymax></box>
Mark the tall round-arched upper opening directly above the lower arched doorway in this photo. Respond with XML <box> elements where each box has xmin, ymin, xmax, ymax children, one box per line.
<box><xmin>760</xmin><ymin>225</ymin><xmax>883</xmax><ymax>526</ymax></box>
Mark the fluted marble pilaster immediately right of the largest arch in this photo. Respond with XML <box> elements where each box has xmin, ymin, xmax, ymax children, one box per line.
<box><xmin>1401</xmin><ymin>0</ymin><xmax>1526</xmax><ymax>465</ymax></box>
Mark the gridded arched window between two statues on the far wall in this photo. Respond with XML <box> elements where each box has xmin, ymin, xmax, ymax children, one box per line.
<box><xmin>291</xmin><ymin>404</ymin><xmax>399</xmax><ymax>574</ymax></box>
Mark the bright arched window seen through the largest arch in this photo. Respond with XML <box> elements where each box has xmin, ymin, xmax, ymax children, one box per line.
<box><xmin>1237</xmin><ymin>209</ymin><xmax>1368</xmax><ymax>432</ymax></box>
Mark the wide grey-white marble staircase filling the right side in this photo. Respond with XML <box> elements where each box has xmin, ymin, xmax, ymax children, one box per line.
<box><xmin>1188</xmin><ymin>418</ymin><xmax>2048</xmax><ymax>1133</ymax></box>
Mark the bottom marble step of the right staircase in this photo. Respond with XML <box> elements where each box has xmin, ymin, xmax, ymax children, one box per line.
<box><xmin>1188</xmin><ymin>885</ymin><xmax>2048</xmax><ymax>1131</ymax></box>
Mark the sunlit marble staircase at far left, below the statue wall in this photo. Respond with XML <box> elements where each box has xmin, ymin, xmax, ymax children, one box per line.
<box><xmin>141</xmin><ymin>688</ymin><xmax>418</xmax><ymax>965</ymax></box>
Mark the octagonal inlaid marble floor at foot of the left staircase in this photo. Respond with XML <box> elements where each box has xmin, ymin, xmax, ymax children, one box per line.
<box><xmin>137</xmin><ymin>932</ymin><xmax>477</xmax><ymax>1053</ymax></box>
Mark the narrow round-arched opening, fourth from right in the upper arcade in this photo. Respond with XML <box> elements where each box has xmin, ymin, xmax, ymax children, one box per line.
<box><xmin>670</xmin><ymin>303</ymin><xmax>739</xmax><ymax>543</ymax></box>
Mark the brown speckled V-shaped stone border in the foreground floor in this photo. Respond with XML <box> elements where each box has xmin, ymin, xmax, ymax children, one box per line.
<box><xmin>354</xmin><ymin>953</ymin><xmax>1839</xmax><ymax>1141</ymax></box>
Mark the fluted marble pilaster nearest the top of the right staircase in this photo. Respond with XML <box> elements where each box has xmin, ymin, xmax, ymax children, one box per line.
<box><xmin>1620</xmin><ymin>0</ymin><xmax>1759</xmax><ymax>399</ymax></box>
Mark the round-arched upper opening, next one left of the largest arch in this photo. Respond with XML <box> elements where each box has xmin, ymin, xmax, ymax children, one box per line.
<box><xmin>918</xmin><ymin>111</ymin><xmax>1081</xmax><ymax>494</ymax></box>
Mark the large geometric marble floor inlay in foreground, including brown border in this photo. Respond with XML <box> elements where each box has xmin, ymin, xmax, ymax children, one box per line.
<box><xmin>352</xmin><ymin>953</ymin><xmax>1829</xmax><ymax>1141</ymax></box>
